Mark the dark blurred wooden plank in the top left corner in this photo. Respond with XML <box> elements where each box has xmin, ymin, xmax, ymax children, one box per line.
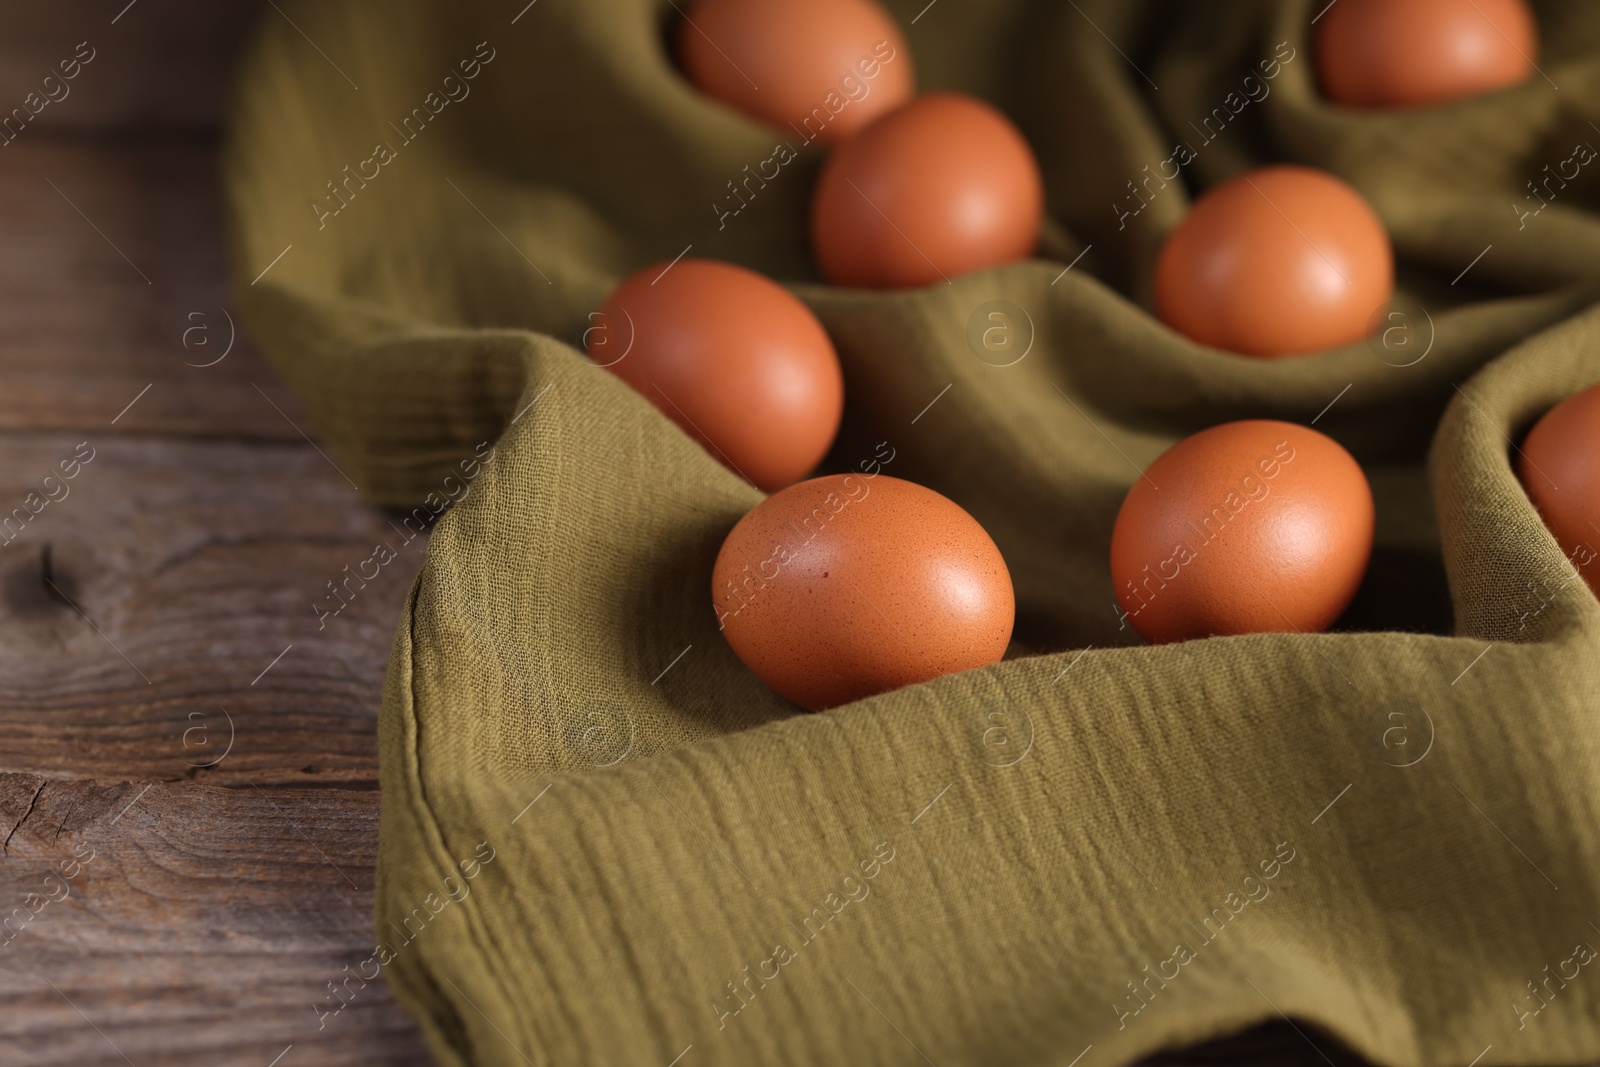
<box><xmin>0</xmin><ymin>0</ymin><xmax>264</xmax><ymax>138</ymax></box>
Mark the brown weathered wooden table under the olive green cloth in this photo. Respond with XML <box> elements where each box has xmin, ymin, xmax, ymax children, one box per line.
<box><xmin>0</xmin><ymin>0</ymin><xmax>1388</xmax><ymax>1067</ymax></box>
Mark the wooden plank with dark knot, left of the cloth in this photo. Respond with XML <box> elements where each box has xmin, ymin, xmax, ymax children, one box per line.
<box><xmin>0</xmin><ymin>429</ymin><xmax>426</xmax><ymax>789</ymax></box>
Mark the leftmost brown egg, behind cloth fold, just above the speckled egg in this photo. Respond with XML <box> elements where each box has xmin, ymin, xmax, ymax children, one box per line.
<box><xmin>584</xmin><ymin>259</ymin><xmax>845</xmax><ymax>491</ymax></box>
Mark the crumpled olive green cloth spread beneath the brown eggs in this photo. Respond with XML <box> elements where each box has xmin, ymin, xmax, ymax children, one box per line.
<box><xmin>227</xmin><ymin>0</ymin><xmax>1600</xmax><ymax>1067</ymax></box>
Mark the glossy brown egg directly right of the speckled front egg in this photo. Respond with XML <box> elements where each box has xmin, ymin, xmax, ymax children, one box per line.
<box><xmin>1110</xmin><ymin>419</ymin><xmax>1373</xmax><ymax>645</ymax></box>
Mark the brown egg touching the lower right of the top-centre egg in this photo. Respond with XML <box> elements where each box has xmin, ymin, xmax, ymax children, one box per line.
<box><xmin>811</xmin><ymin>93</ymin><xmax>1045</xmax><ymax>290</ymax></box>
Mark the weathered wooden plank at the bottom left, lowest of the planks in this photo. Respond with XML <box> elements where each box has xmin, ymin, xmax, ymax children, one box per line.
<box><xmin>0</xmin><ymin>774</ymin><xmax>432</xmax><ymax>1067</ymax></box>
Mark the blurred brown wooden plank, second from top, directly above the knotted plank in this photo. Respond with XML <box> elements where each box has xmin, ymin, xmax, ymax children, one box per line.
<box><xmin>0</xmin><ymin>136</ymin><xmax>314</xmax><ymax>442</ymax></box>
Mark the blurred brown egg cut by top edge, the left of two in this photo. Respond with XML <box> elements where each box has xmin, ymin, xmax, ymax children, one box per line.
<box><xmin>678</xmin><ymin>0</ymin><xmax>915</xmax><ymax>147</ymax></box>
